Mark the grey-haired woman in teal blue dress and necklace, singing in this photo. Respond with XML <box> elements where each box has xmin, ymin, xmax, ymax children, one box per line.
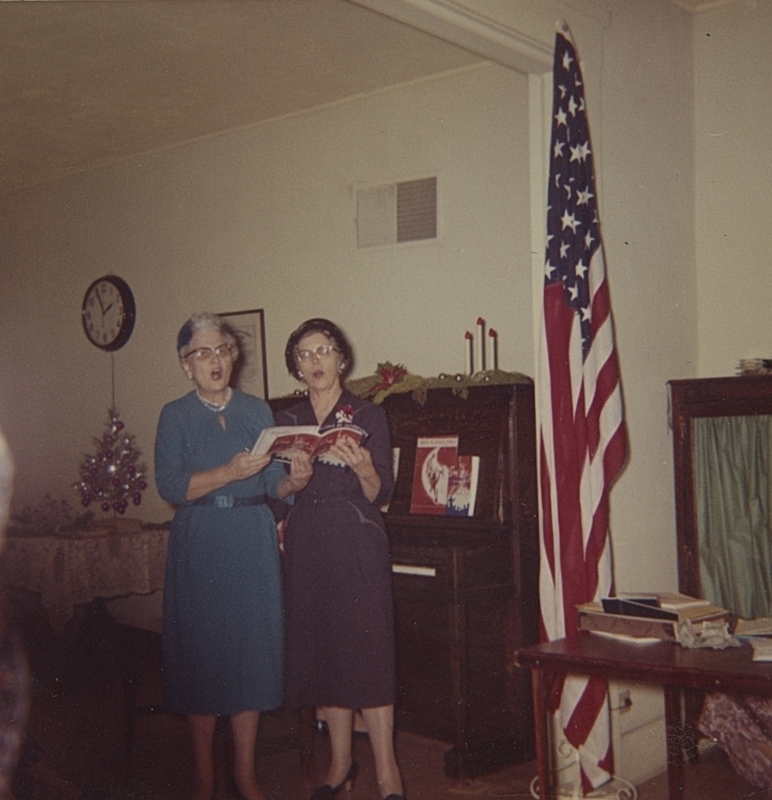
<box><xmin>155</xmin><ymin>314</ymin><xmax>309</xmax><ymax>800</ymax></box>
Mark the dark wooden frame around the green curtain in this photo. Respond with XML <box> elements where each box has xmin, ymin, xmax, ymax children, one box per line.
<box><xmin>668</xmin><ymin>375</ymin><xmax>772</xmax><ymax>597</ymax></box>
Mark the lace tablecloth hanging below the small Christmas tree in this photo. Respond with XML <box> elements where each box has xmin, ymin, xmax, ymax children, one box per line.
<box><xmin>0</xmin><ymin>530</ymin><xmax>169</xmax><ymax>630</ymax></box>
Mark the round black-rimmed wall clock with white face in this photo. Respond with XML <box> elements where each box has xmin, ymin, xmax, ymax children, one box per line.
<box><xmin>81</xmin><ymin>275</ymin><xmax>136</xmax><ymax>352</ymax></box>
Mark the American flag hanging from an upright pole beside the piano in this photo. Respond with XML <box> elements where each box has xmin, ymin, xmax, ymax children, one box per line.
<box><xmin>539</xmin><ymin>26</ymin><xmax>627</xmax><ymax>793</ymax></box>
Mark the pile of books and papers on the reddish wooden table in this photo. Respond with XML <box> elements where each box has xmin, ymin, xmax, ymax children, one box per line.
<box><xmin>577</xmin><ymin>592</ymin><xmax>731</xmax><ymax>641</ymax></box>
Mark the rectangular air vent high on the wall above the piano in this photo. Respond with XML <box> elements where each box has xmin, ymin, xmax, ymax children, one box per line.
<box><xmin>357</xmin><ymin>176</ymin><xmax>437</xmax><ymax>247</ymax></box>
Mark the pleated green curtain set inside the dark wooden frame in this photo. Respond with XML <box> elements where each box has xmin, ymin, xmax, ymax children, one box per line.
<box><xmin>693</xmin><ymin>415</ymin><xmax>772</xmax><ymax>619</ymax></box>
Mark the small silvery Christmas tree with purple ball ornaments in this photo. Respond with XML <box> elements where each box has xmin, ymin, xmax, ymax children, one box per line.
<box><xmin>74</xmin><ymin>407</ymin><xmax>147</xmax><ymax>516</ymax></box>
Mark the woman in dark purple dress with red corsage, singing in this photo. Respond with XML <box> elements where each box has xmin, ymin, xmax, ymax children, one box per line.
<box><xmin>276</xmin><ymin>319</ymin><xmax>403</xmax><ymax>800</ymax></box>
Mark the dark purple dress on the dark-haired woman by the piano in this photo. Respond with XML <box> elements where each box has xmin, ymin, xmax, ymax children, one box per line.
<box><xmin>276</xmin><ymin>391</ymin><xmax>396</xmax><ymax>708</ymax></box>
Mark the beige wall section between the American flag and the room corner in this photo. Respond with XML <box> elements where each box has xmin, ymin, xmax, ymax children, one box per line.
<box><xmin>593</xmin><ymin>2</ymin><xmax>697</xmax><ymax>591</ymax></box>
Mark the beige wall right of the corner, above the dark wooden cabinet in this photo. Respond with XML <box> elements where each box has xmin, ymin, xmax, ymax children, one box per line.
<box><xmin>693</xmin><ymin>0</ymin><xmax>772</xmax><ymax>376</ymax></box>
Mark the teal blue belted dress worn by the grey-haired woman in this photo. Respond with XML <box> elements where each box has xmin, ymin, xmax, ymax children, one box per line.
<box><xmin>155</xmin><ymin>391</ymin><xmax>285</xmax><ymax>716</ymax></box>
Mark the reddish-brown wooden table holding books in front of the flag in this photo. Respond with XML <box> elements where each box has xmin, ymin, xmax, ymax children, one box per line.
<box><xmin>516</xmin><ymin>633</ymin><xmax>772</xmax><ymax>800</ymax></box>
